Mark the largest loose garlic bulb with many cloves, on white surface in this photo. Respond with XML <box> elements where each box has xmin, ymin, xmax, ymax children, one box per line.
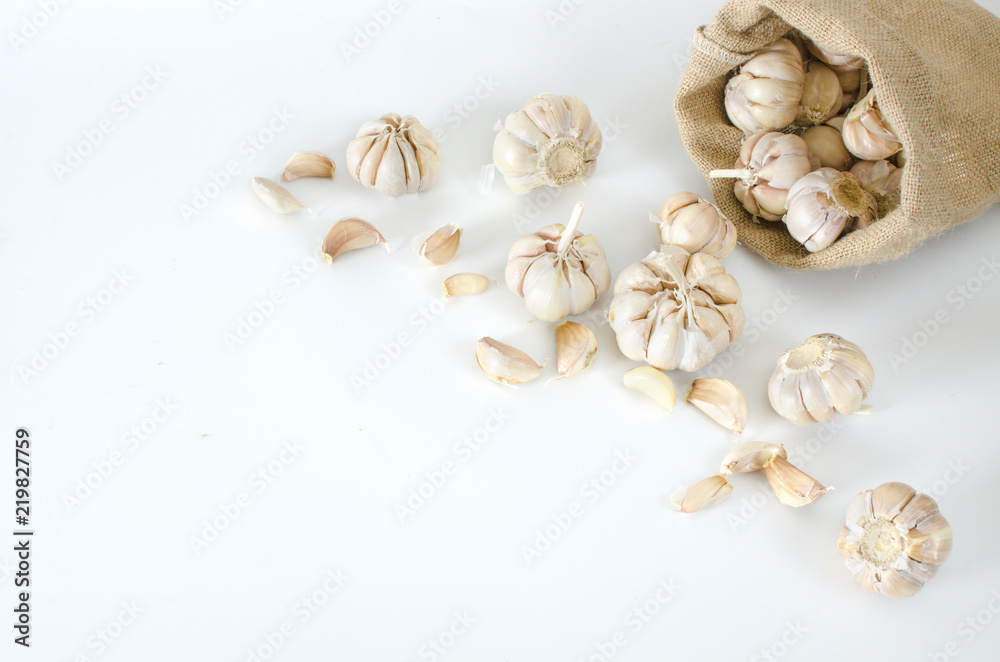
<box><xmin>608</xmin><ymin>246</ymin><xmax>746</xmax><ymax>372</ymax></box>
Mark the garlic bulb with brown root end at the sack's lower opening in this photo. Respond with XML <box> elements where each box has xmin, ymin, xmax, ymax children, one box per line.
<box><xmin>785</xmin><ymin>168</ymin><xmax>878</xmax><ymax>253</ymax></box>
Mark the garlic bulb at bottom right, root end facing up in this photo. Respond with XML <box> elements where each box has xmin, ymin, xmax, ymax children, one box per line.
<box><xmin>837</xmin><ymin>483</ymin><xmax>952</xmax><ymax>598</ymax></box>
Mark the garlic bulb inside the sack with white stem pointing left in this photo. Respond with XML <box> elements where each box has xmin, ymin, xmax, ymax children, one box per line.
<box><xmin>708</xmin><ymin>131</ymin><xmax>819</xmax><ymax>221</ymax></box>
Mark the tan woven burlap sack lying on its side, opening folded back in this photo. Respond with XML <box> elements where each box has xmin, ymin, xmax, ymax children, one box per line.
<box><xmin>674</xmin><ymin>0</ymin><xmax>1000</xmax><ymax>269</ymax></box>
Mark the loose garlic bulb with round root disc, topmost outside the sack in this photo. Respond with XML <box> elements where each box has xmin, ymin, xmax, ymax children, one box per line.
<box><xmin>493</xmin><ymin>94</ymin><xmax>601</xmax><ymax>193</ymax></box>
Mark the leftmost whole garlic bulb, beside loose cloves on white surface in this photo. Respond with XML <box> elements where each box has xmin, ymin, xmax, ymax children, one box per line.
<box><xmin>347</xmin><ymin>113</ymin><xmax>441</xmax><ymax>198</ymax></box>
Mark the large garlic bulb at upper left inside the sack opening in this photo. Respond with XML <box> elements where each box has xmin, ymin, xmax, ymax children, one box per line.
<box><xmin>725</xmin><ymin>39</ymin><xmax>805</xmax><ymax>134</ymax></box>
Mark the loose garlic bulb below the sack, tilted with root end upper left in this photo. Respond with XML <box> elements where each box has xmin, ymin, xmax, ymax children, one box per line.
<box><xmin>767</xmin><ymin>333</ymin><xmax>875</xmax><ymax>426</ymax></box>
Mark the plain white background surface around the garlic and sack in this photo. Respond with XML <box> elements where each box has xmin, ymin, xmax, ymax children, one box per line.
<box><xmin>0</xmin><ymin>0</ymin><xmax>1000</xmax><ymax>662</ymax></box>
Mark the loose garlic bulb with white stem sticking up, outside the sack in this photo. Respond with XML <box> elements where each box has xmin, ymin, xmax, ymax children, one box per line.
<box><xmin>504</xmin><ymin>202</ymin><xmax>611</xmax><ymax>322</ymax></box>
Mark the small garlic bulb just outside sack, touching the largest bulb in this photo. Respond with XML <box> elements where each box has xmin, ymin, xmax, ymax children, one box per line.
<box><xmin>650</xmin><ymin>191</ymin><xmax>736</xmax><ymax>260</ymax></box>
